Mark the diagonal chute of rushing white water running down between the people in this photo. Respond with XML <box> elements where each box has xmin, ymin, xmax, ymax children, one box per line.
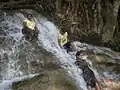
<box><xmin>38</xmin><ymin>21</ymin><xmax>87</xmax><ymax>90</ymax></box>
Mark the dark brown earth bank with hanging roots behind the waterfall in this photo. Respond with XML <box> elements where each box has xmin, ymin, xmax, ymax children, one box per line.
<box><xmin>0</xmin><ymin>0</ymin><xmax>120</xmax><ymax>51</ymax></box>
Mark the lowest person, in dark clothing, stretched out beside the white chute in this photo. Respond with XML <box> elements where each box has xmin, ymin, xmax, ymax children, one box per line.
<box><xmin>75</xmin><ymin>51</ymin><xmax>100</xmax><ymax>90</ymax></box>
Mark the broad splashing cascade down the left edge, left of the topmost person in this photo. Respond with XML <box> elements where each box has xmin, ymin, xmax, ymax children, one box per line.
<box><xmin>0</xmin><ymin>12</ymin><xmax>40</xmax><ymax>90</ymax></box>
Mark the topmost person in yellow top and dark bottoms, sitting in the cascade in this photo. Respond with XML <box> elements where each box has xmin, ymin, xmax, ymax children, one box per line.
<box><xmin>22</xmin><ymin>14</ymin><xmax>39</xmax><ymax>40</ymax></box>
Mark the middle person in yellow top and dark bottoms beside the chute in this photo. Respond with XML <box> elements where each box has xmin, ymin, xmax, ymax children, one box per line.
<box><xmin>58</xmin><ymin>31</ymin><xmax>75</xmax><ymax>52</ymax></box>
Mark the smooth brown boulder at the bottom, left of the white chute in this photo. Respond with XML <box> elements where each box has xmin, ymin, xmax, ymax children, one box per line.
<box><xmin>13</xmin><ymin>69</ymin><xmax>78</xmax><ymax>90</ymax></box>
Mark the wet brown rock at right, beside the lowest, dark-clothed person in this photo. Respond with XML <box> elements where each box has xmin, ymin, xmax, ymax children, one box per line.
<box><xmin>88</xmin><ymin>54</ymin><xmax>120</xmax><ymax>79</ymax></box>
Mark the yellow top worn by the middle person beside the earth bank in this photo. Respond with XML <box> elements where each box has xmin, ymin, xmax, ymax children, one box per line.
<box><xmin>58</xmin><ymin>32</ymin><xmax>68</xmax><ymax>47</ymax></box>
